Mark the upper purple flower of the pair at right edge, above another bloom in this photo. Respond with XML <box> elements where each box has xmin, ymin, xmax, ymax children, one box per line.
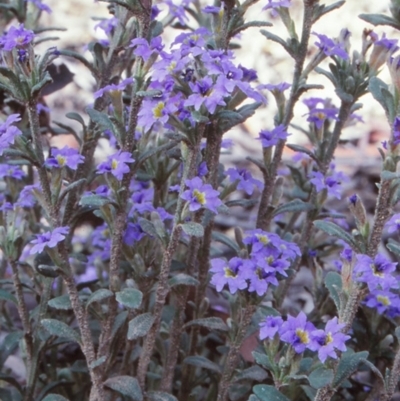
<box><xmin>353</xmin><ymin>254</ymin><xmax>398</xmax><ymax>291</ymax></box>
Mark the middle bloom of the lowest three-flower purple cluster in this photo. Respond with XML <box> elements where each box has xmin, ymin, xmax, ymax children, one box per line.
<box><xmin>279</xmin><ymin>312</ymin><xmax>317</xmax><ymax>354</ymax></box>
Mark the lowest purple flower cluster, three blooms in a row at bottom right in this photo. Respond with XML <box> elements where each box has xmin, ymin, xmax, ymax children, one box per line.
<box><xmin>260</xmin><ymin>312</ymin><xmax>350</xmax><ymax>363</ymax></box>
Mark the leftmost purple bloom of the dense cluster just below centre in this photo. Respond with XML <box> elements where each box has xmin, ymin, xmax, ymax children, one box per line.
<box><xmin>210</xmin><ymin>257</ymin><xmax>249</xmax><ymax>294</ymax></box>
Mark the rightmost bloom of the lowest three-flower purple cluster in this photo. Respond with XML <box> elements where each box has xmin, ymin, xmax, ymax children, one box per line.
<box><xmin>311</xmin><ymin>317</ymin><xmax>350</xmax><ymax>363</ymax></box>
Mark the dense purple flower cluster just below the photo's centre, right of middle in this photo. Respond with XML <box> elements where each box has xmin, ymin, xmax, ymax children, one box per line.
<box><xmin>210</xmin><ymin>229</ymin><xmax>300</xmax><ymax>297</ymax></box>
